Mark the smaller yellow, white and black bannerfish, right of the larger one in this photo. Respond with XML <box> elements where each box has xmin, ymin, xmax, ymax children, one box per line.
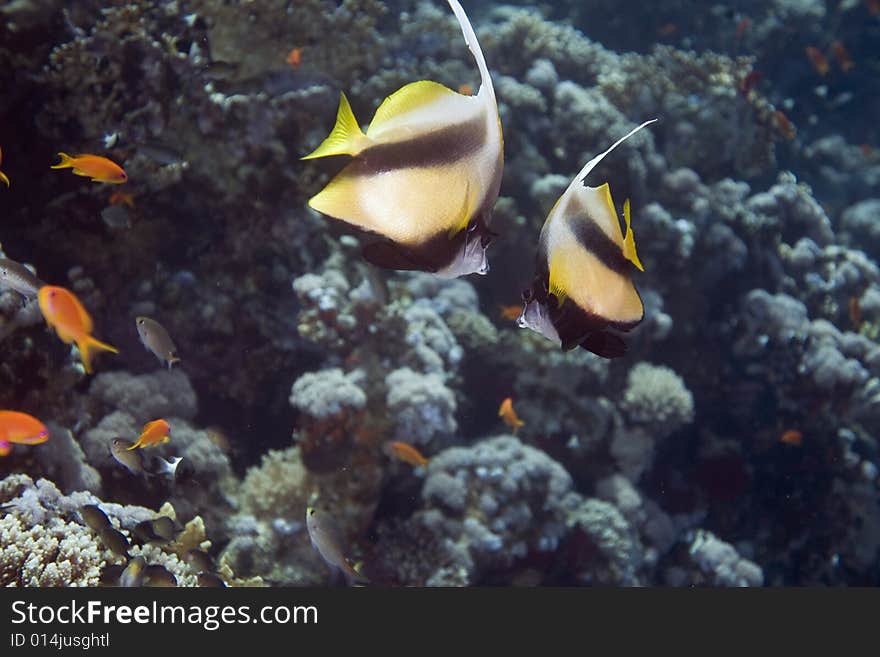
<box><xmin>517</xmin><ymin>119</ymin><xmax>657</xmax><ymax>358</ymax></box>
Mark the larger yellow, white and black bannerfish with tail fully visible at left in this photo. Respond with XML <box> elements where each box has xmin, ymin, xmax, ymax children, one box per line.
<box><xmin>302</xmin><ymin>0</ymin><xmax>504</xmax><ymax>278</ymax></box>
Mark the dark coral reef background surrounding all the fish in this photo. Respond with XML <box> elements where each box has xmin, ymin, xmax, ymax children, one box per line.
<box><xmin>0</xmin><ymin>0</ymin><xmax>880</xmax><ymax>586</ymax></box>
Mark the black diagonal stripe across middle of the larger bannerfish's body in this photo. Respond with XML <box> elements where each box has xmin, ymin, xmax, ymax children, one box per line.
<box><xmin>347</xmin><ymin>116</ymin><xmax>487</xmax><ymax>176</ymax></box>
